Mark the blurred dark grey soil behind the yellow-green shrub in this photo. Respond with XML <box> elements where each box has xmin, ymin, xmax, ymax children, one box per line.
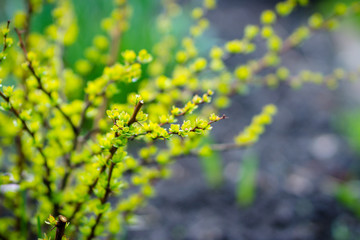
<box><xmin>126</xmin><ymin>0</ymin><xmax>360</xmax><ymax>240</ymax></box>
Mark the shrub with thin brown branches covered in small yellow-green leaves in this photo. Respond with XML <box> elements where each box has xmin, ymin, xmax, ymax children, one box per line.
<box><xmin>0</xmin><ymin>0</ymin><xmax>360</xmax><ymax>240</ymax></box>
